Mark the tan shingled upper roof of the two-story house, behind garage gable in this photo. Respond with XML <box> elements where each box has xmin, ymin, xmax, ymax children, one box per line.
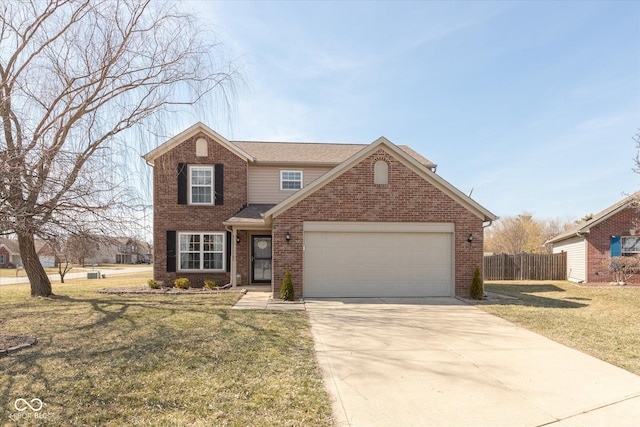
<box><xmin>143</xmin><ymin>123</ymin><xmax>436</xmax><ymax>169</ymax></box>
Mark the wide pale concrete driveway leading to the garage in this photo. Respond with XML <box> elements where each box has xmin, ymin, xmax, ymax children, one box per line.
<box><xmin>305</xmin><ymin>298</ymin><xmax>640</xmax><ymax>426</ymax></box>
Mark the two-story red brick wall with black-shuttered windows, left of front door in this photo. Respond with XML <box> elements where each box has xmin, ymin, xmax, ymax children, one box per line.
<box><xmin>153</xmin><ymin>134</ymin><xmax>247</xmax><ymax>286</ymax></box>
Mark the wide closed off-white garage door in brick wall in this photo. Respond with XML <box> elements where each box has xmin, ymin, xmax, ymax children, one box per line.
<box><xmin>304</xmin><ymin>222</ymin><xmax>454</xmax><ymax>297</ymax></box>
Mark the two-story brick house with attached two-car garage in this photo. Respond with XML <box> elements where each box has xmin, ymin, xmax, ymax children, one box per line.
<box><xmin>144</xmin><ymin>123</ymin><xmax>496</xmax><ymax>298</ymax></box>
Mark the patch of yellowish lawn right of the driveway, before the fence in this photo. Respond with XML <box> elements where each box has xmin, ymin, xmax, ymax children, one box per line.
<box><xmin>477</xmin><ymin>282</ymin><xmax>640</xmax><ymax>375</ymax></box>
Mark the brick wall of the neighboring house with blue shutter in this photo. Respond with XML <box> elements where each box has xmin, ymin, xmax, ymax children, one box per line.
<box><xmin>587</xmin><ymin>207</ymin><xmax>640</xmax><ymax>283</ymax></box>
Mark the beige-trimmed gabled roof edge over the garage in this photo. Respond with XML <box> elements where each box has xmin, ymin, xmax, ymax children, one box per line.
<box><xmin>264</xmin><ymin>137</ymin><xmax>497</xmax><ymax>223</ymax></box>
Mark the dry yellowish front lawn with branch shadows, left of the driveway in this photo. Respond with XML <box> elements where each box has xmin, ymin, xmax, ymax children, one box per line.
<box><xmin>0</xmin><ymin>273</ymin><xmax>332</xmax><ymax>426</ymax></box>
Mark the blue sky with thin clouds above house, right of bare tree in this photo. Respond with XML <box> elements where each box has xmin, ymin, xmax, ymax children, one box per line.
<box><xmin>172</xmin><ymin>1</ymin><xmax>640</xmax><ymax>220</ymax></box>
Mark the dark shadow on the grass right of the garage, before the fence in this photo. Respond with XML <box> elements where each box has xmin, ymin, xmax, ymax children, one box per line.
<box><xmin>485</xmin><ymin>283</ymin><xmax>589</xmax><ymax>308</ymax></box>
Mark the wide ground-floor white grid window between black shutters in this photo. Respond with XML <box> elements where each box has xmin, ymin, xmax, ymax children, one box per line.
<box><xmin>178</xmin><ymin>233</ymin><xmax>225</xmax><ymax>271</ymax></box>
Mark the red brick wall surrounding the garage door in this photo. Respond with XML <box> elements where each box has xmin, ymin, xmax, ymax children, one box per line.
<box><xmin>273</xmin><ymin>149</ymin><xmax>483</xmax><ymax>297</ymax></box>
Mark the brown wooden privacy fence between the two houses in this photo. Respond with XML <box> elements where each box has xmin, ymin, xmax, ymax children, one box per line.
<box><xmin>484</xmin><ymin>252</ymin><xmax>567</xmax><ymax>280</ymax></box>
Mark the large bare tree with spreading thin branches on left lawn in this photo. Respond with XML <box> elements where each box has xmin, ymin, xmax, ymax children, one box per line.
<box><xmin>0</xmin><ymin>0</ymin><xmax>236</xmax><ymax>296</ymax></box>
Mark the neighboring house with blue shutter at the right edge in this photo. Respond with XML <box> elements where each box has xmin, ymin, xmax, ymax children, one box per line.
<box><xmin>547</xmin><ymin>193</ymin><xmax>640</xmax><ymax>283</ymax></box>
